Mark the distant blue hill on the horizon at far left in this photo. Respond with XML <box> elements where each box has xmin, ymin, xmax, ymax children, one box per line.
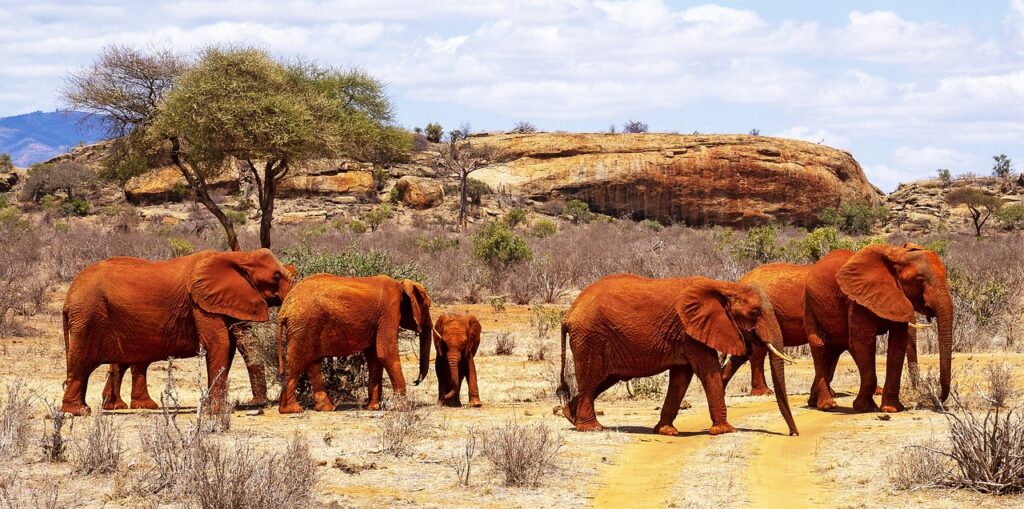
<box><xmin>0</xmin><ymin>112</ymin><xmax>106</xmax><ymax>168</ymax></box>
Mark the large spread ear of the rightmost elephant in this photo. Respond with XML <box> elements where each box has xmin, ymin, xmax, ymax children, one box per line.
<box><xmin>836</xmin><ymin>245</ymin><xmax>914</xmax><ymax>322</ymax></box>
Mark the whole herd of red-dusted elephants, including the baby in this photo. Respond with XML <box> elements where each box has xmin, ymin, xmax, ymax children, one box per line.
<box><xmin>61</xmin><ymin>244</ymin><xmax>952</xmax><ymax>435</ymax></box>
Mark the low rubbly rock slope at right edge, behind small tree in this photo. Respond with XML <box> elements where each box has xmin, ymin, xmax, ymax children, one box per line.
<box><xmin>885</xmin><ymin>177</ymin><xmax>1024</xmax><ymax>235</ymax></box>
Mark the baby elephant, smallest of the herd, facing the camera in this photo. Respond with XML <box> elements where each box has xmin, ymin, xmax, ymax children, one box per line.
<box><xmin>434</xmin><ymin>314</ymin><xmax>482</xmax><ymax>407</ymax></box>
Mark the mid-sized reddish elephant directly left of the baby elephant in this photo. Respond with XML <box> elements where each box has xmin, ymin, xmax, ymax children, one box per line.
<box><xmin>278</xmin><ymin>273</ymin><xmax>432</xmax><ymax>414</ymax></box>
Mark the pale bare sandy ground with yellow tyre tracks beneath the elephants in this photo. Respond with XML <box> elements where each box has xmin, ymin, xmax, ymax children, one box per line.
<box><xmin>0</xmin><ymin>293</ymin><xmax>1024</xmax><ymax>508</ymax></box>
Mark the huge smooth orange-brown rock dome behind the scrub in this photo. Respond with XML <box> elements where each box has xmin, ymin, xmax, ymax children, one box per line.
<box><xmin>473</xmin><ymin>133</ymin><xmax>882</xmax><ymax>226</ymax></box>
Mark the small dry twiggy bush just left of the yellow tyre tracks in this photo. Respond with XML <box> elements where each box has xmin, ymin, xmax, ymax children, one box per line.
<box><xmin>483</xmin><ymin>417</ymin><xmax>565</xmax><ymax>486</ymax></box>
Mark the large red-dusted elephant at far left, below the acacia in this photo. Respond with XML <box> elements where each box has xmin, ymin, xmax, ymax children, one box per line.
<box><xmin>61</xmin><ymin>249</ymin><xmax>293</xmax><ymax>415</ymax></box>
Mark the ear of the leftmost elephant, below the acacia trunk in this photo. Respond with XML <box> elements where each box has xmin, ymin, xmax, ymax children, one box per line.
<box><xmin>188</xmin><ymin>252</ymin><xmax>270</xmax><ymax>322</ymax></box>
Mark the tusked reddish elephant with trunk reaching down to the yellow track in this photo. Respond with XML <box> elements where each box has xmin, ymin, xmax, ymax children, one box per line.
<box><xmin>558</xmin><ymin>274</ymin><xmax>799</xmax><ymax>435</ymax></box>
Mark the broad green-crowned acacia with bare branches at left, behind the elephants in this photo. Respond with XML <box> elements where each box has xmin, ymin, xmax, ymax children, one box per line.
<box><xmin>66</xmin><ymin>46</ymin><xmax>412</xmax><ymax>250</ymax></box>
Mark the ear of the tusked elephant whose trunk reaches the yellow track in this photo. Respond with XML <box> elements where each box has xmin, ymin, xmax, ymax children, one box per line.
<box><xmin>676</xmin><ymin>280</ymin><xmax>746</xmax><ymax>355</ymax></box>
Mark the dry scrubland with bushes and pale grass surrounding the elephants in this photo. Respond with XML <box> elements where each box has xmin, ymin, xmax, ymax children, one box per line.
<box><xmin>0</xmin><ymin>193</ymin><xmax>1024</xmax><ymax>507</ymax></box>
